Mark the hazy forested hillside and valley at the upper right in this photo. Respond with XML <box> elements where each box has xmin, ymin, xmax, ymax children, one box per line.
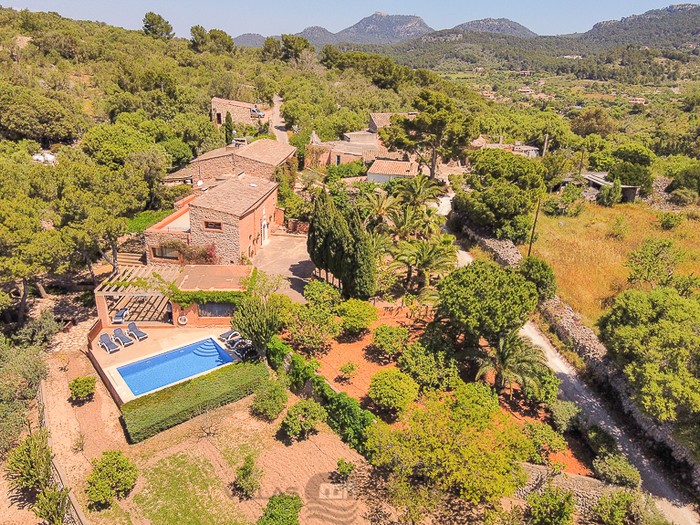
<box><xmin>369</xmin><ymin>4</ymin><xmax>700</xmax><ymax>75</ymax></box>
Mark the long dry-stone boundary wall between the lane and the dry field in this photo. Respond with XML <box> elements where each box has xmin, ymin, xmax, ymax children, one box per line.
<box><xmin>462</xmin><ymin>220</ymin><xmax>700</xmax><ymax>492</ymax></box>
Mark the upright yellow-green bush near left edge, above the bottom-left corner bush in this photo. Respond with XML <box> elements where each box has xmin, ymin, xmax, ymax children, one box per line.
<box><xmin>5</xmin><ymin>429</ymin><xmax>53</xmax><ymax>492</ymax></box>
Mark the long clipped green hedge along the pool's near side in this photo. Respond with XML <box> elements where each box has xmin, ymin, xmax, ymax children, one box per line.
<box><xmin>121</xmin><ymin>363</ymin><xmax>269</xmax><ymax>443</ymax></box>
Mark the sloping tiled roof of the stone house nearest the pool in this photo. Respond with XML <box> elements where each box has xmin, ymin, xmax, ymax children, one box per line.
<box><xmin>190</xmin><ymin>175</ymin><xmax>278</xmax><ymax>217</ymax></box>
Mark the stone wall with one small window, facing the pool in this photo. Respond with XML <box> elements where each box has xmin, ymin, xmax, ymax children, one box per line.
<box><xmin>190</xmin><ymin>204</ymin><xmax>241</xmax><ymax>264</ymax></box>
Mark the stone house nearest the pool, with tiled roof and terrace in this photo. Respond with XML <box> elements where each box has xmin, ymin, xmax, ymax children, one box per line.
<box><xmin>144</xmin><ymin>174</ymin><xmax>282</xmax><ymax>265</ymax></box>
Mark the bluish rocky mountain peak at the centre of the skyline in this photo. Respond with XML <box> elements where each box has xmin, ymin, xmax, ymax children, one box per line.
<box><xmin>335</xmin><ymin>13</ymin><xmax>433</xmax><ymax>44</ymax></box>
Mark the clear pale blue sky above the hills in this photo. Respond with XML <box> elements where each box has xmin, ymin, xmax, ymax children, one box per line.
<box><xmin>0</xmin><ymin>0</ymin><xmax>679</xmax><ymax>37</ymax></box>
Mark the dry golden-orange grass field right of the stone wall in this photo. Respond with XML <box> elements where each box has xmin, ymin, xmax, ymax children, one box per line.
<box><xmin>521</xmin><ymin>203</ymin><xmax>700</xmax><ymax>327</ymax></box>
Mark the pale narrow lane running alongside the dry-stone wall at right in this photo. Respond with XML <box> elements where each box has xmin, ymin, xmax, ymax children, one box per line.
<box><xmin>457</xmin><ymin>244</ymin><xmax>700</xmax><ymax>525</ymax></box>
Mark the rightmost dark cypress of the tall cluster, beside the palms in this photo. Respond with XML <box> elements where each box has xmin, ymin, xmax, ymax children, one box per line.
<box><xmin>341</xmin><ymin>210</ymin><xmax>377</xmax><ymax>300</ymax></box>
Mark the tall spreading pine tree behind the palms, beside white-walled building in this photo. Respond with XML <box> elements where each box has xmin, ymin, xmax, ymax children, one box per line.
<box><xmin>380</xmin><ymin>89</ymin><xmax>476</xmax><ymax>178</ymax></box>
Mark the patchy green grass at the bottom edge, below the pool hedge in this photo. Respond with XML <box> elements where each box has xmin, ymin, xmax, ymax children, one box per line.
<box><xmin>134</xmin><ymin>454</ymin><xmax>247</xmax><ymax>525</ymax></box>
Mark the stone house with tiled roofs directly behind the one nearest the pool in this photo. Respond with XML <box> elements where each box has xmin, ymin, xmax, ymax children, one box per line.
<box><xmin>166</xmin><ymin>139</ymin><xmax>297</xmax><ymax>188</ymax></box>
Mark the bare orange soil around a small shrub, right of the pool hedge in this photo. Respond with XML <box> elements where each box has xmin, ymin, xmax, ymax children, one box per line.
<box><xmin>318</xmin><ymin>308</ymin><xmax>422</xmax><ymax>401</ymax></box>
